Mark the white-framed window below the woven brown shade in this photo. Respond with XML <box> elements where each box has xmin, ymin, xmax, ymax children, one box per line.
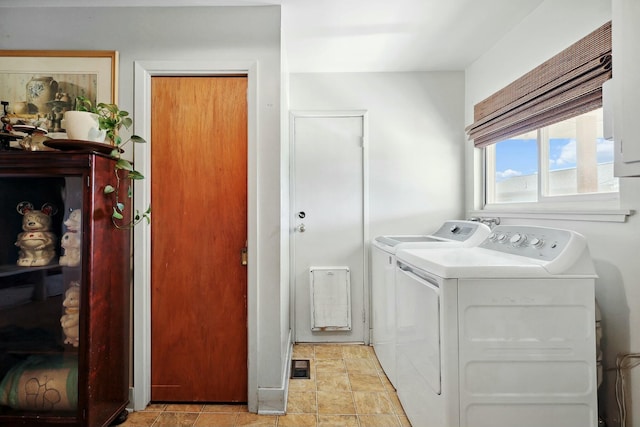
<box><xmin>485</xmin><ymin>108</ymin><xmax>618</xmax><ymax>204</ymax></box>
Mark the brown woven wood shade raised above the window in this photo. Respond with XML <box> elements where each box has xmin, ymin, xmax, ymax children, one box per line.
<box><xmin>466</xmin><ymin>22</ymin><xmax>611</xmax><ymax>148</ymax></box>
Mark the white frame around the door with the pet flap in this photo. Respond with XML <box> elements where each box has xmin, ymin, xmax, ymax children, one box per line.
<box><xmin>289</xmin><ymin>110</ymin><xmax>371</xmax><ymax>345</ymax></box>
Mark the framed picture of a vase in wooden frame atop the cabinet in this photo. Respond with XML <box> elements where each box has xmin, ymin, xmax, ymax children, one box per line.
<box><xmin>0</xmin><ymin>50</ymin><xmax>118</xmax><ymax>132</ymax></box>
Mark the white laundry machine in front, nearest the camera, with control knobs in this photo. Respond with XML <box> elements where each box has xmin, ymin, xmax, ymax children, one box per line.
<box><xmin>396</xmin><ymin>225</ymin><xmax>598</xmax><ymax>427</ymax></box>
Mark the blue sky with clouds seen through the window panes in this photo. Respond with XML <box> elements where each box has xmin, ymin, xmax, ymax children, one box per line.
<box><xmin>495</xmin><ymin>138</ymin><xmax>613</xmax><ymax>181</ymax></box>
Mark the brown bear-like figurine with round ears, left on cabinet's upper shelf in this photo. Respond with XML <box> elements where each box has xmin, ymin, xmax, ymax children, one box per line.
<box><xmin>16</xmin><ymin>202</ymin><xmax>56</xmax><ymax>267</ymax></box>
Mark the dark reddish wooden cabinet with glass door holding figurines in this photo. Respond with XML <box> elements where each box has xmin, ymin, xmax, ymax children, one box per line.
<box><xmin>0</xmin><ymin>151</ymin><xmax>131</xmax><ymax>427</ymax></box>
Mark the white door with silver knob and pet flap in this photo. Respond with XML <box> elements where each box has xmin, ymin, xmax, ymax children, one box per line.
<box><xmin>291</xmin><ymin>115</ymin><xmax>368</xmax><ymax>342</ymax></box>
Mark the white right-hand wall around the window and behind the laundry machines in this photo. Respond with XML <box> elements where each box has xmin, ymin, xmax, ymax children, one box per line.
<box><xmin>465</xmin><ymin>0</ymin><xmax>640</xmax><ymax>427</ymax></box>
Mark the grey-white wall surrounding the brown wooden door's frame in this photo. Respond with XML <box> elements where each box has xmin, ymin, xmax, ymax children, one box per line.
<box><xmin>0</xmin><ymin>6</ymin><xmax>289</xmax><ymax>411</ymax></box>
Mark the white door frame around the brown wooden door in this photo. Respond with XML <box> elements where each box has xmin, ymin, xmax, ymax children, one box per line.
<box><xmin>129</xmin><ymin>61</ymin><xmax>258</xmax><ymax>411</ymax></box>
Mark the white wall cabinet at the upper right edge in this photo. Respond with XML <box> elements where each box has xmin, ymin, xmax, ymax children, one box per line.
<box><xmin>611</xmin><ymin>0</ymin><xmax>640</xmax><ymax>176</ymax></box>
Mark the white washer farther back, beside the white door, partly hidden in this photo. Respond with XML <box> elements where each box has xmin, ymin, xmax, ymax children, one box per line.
<box><xmin>371</xmin><ymin>220</ymin><xmax>490</xmax><ymax>387</ymax></box>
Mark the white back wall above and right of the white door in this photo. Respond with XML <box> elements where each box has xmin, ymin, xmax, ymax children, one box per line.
<box><xmin>290</xmin><ymin>72</ymin><xmax>464</xmax><ymax>238</ymax></box>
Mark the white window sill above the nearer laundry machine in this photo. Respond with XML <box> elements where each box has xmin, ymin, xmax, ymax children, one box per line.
<box><xmin>469</xmin><ymin>208</ymin><xmax>635</xmax><ymax>222</ymax></box>
